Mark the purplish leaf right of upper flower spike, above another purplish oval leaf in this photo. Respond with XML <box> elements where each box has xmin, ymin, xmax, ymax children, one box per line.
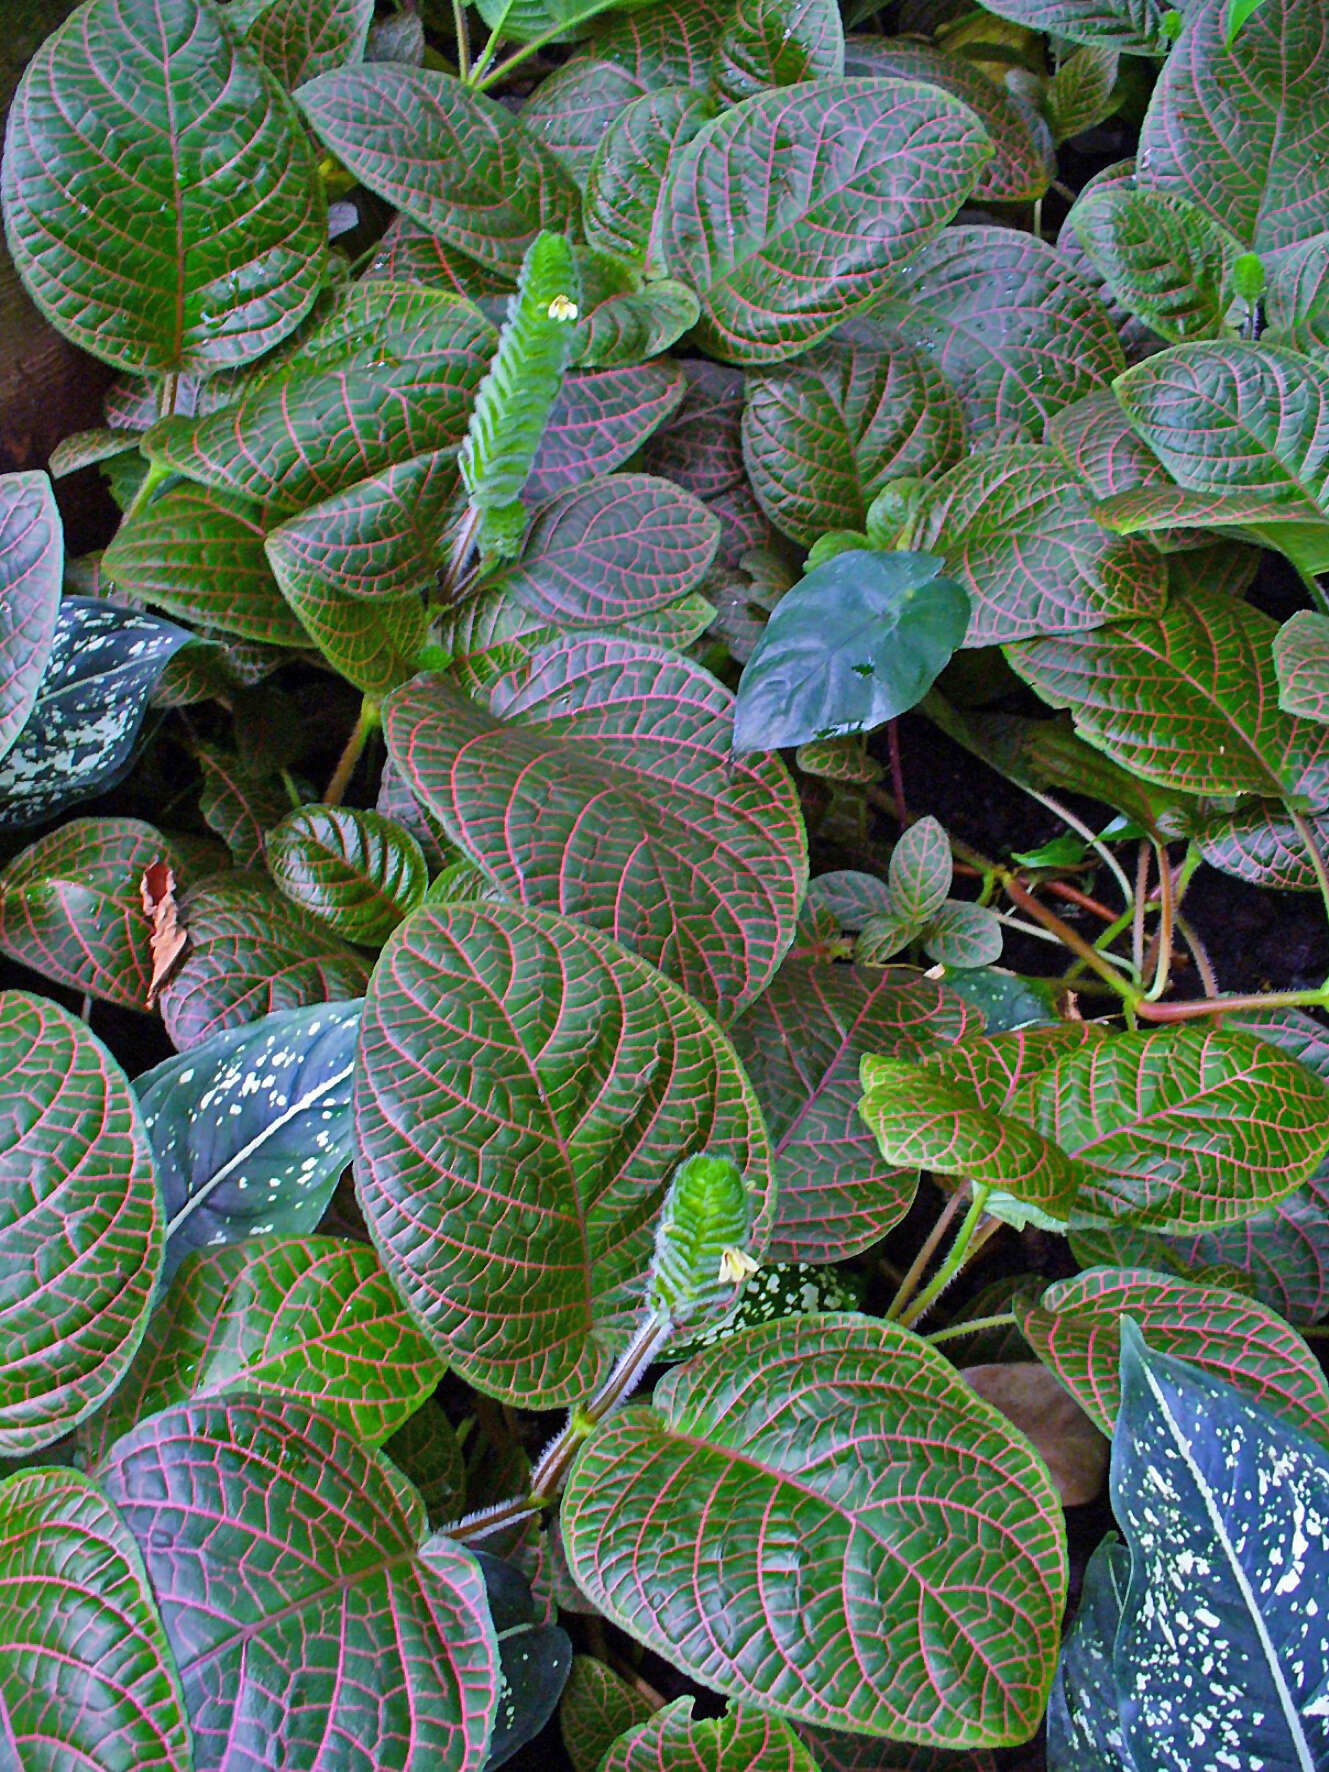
<box><xmin>525</xmin><ymin>363</ymin><xmax>688</xmax><ymax>500</ymax></box>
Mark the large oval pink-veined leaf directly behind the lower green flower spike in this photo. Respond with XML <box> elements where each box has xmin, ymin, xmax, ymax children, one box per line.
<box><xmin>354</xmin><ymin>902</ymin><xmax>773</xmax><ymax>1409</ymax></box>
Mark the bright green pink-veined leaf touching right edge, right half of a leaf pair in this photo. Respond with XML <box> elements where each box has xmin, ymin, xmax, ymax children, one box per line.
<box><xmin>1012</xmin><ymin>1028</ymin><xmax>1329</xmax><ymax>1232</ymax></box>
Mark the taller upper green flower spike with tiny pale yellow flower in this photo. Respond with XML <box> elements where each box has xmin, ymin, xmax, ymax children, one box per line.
<box><xmin>461</xmin><ymin>234</ymin><xmax>581</xmax><ymax>517</ymax></box>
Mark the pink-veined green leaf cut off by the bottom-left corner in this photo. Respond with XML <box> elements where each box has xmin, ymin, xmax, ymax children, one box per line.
<box><xmin>0</xmin><ymin>1471</ymin><xmax>193</xmax><ymax>1772</ymax></box>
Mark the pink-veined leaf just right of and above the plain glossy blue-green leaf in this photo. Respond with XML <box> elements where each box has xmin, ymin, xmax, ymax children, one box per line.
<box><xmin>920</xmin><ymin>443</ymin><xmax>1168</xmax><ymax>647</ymax></box>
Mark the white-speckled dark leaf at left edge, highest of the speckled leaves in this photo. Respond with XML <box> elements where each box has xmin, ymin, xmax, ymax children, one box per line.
<box><xmin>0</xmin><ymin>597</ymin><xmax>191</xmax><ymax>829</ymax></box>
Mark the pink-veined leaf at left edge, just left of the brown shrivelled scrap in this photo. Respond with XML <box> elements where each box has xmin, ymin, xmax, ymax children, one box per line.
<box><xmin>0</xmin><ymin>819</ymin><xmax>183</xmax><ymax>1008</ymax></box>
